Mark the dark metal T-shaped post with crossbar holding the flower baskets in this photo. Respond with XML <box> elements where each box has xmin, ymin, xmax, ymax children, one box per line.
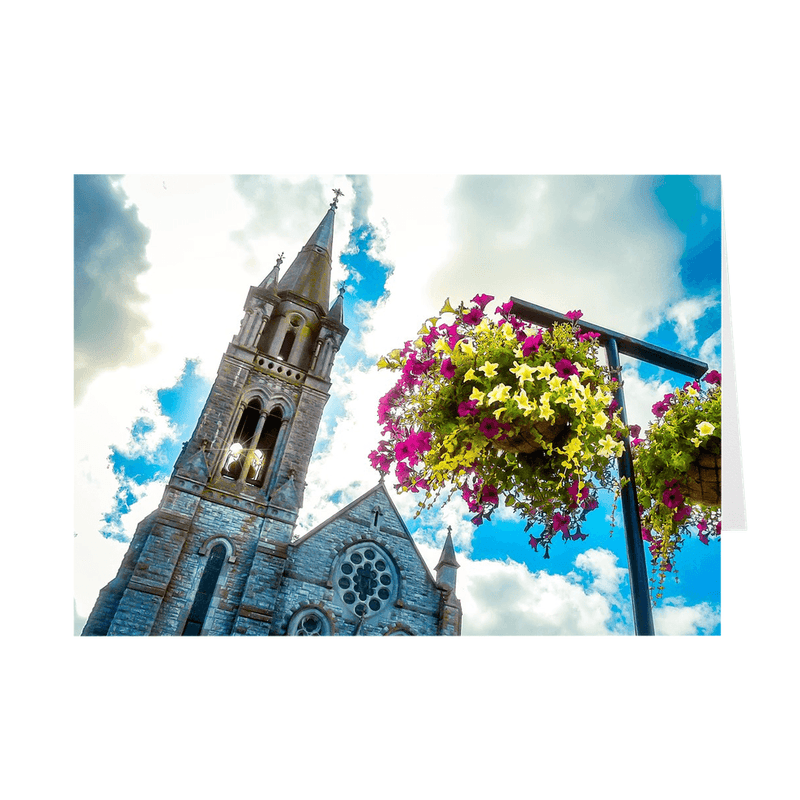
<box><xmin>511</xmin><ymin>297</ymin><xmax>708</xmax><ymax>636</ymax></box>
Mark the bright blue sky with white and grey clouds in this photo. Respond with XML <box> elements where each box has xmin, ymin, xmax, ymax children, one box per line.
<box><xmin>74</xmin><ymin>174</ymin><xmax>721</xmax><ymax>635</ymax></box>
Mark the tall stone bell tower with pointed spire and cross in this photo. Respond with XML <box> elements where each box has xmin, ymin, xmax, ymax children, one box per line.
<box><xmin>83</xmin><ymin>189</ymin><xmax>348</xmax><ymax>636</ymax></box>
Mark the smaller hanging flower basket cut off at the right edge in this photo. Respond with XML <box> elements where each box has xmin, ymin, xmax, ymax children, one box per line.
<box><xmin>631</xmin><ymin>370</ymin><xmax>722</xmax><ymax>597</ymax></box>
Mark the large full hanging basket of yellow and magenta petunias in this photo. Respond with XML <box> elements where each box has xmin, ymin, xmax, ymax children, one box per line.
<box><xmin>370</xmin><ymin>294</ymin><xmax>627</xmax><ymax>557</ymax></box>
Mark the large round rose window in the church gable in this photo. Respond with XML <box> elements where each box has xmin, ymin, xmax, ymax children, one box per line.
<box><xmin>334</xmin><ymin>543</ymin><xmax>397</xmax><ymax>617</ymax></box>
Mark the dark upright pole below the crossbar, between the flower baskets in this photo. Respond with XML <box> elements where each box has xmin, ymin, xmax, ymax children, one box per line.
<box><xmin>605</xmin><ymin>338</ymin><xmax>655</xmax><ymax>636</ymax></box>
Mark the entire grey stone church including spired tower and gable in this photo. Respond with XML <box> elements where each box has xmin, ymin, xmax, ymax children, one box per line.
<box><xmin>82</xmin><ymin>190</ymin><xmax>461</xmax><ymax>636</ymax></box>
